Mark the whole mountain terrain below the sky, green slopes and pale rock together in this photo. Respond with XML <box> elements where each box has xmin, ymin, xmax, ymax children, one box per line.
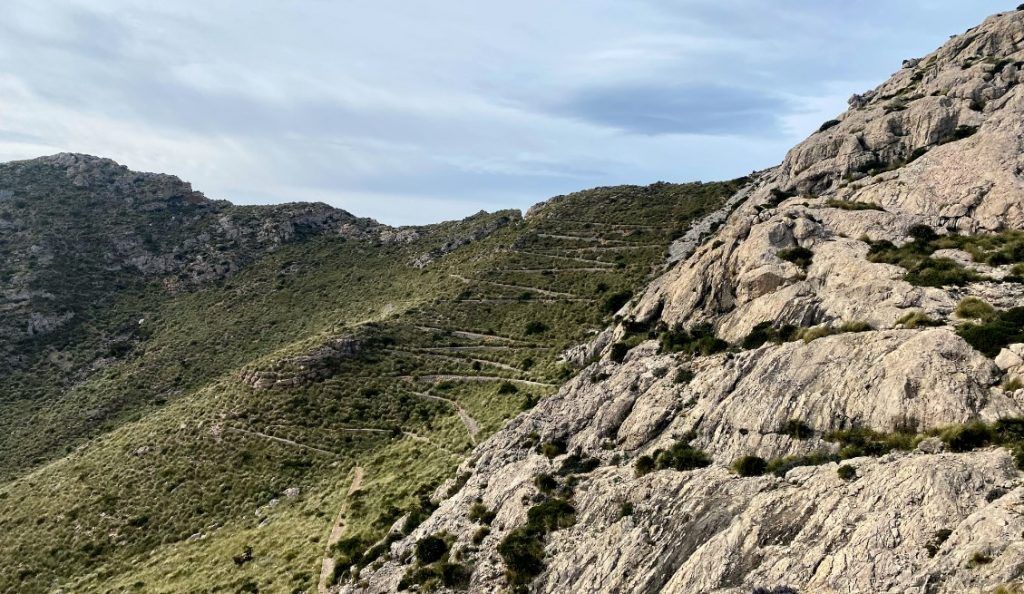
<box><xmin>6</xmin><ymin>6</ymin><xmax>1024</xmax><ymax>594</ymax></box>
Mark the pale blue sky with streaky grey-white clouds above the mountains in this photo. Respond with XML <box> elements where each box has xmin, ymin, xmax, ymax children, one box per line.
<box><xmin>0</xmin><ymin>0</ymin><xmax>1016</xmax><ymax>224</ymax></box>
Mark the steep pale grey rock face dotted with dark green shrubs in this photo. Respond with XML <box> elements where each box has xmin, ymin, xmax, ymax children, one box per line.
<box><xmin>339</xmin><ymin>11</ymin><xmax>1024</xmax><ymax>594</ymax></box>
